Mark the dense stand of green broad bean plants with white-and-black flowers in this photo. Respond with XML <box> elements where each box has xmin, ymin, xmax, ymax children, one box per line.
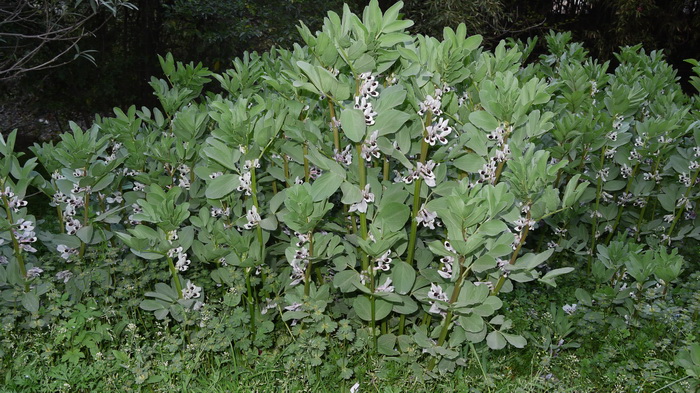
<box><xmin>0</xmin><ymin>1</ymin><xmax>700</xmax><ymax>372</ymax></box>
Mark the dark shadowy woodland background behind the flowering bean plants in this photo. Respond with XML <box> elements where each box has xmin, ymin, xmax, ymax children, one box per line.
<box><xmin>0</xmin><ymin>0</ymin><xmax>700</xmax><ymax>147</ymax></box>
